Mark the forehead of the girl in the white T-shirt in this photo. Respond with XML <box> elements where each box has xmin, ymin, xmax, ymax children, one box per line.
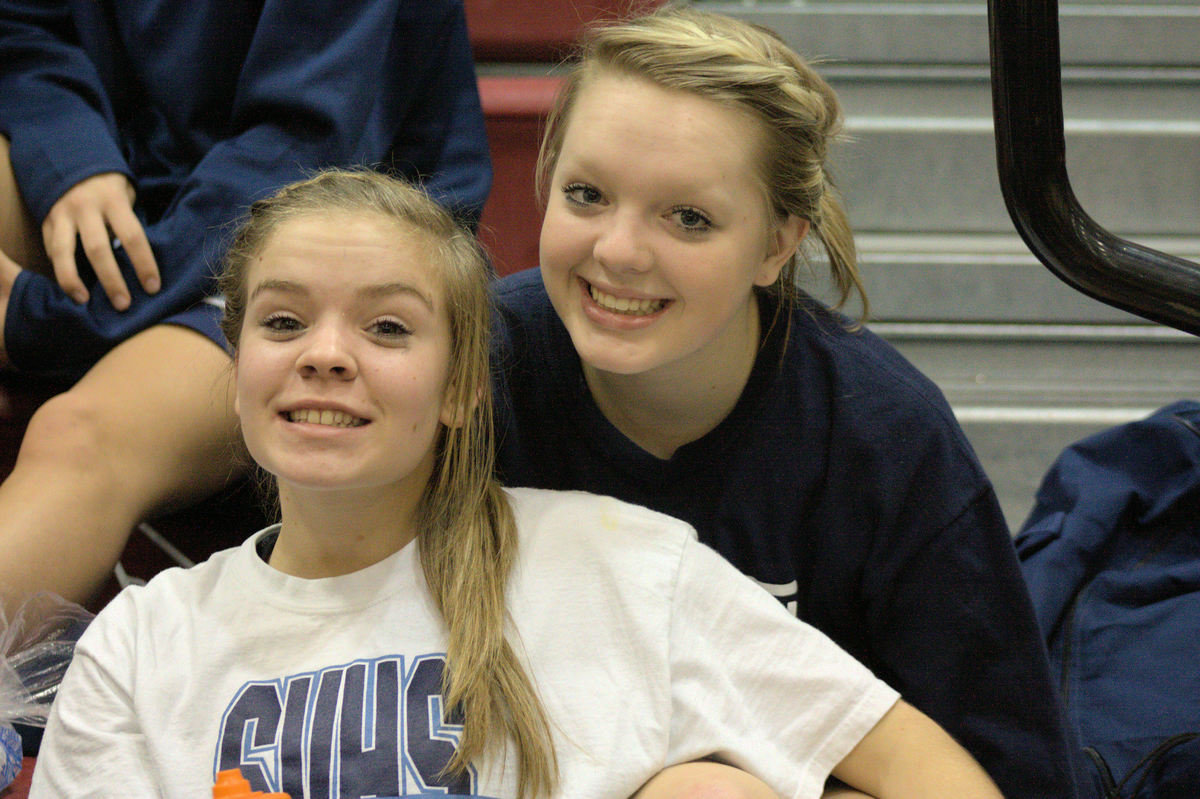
<box><xmin>246</xmin><ymin>211</ymin><xmax>442</xmax><ymax>299</ymax></box>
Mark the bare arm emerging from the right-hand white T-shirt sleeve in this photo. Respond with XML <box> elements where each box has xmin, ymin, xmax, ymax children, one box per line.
<box><xmin>827</xmin><ymin>701</ymin><xmax>1002</xmax><ymax>799</ymax></box>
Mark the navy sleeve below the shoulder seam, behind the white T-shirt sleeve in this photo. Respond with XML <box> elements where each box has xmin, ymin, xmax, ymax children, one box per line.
<box><xmin>864</xmin><ymin>486</ymin><xmax>1072</xmax><ymax>797</ymax></box>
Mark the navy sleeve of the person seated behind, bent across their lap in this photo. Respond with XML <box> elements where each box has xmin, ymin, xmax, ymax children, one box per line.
<box><xmin>5</xmin><ymin>0</ymin><xmax>491</xmax><ymax>376</ymax></box>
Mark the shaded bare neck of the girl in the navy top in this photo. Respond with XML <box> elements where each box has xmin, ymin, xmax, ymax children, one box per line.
<box><xmin>583</xmin><ymin>292</ymin><xmax>760</xmax><ymax>458</ymax></box>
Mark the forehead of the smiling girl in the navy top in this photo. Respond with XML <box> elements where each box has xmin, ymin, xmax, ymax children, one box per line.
<box><xmin>559</xmin><ymin>70</ymin><xmax>764</xmax><ymax>184</ymax></box>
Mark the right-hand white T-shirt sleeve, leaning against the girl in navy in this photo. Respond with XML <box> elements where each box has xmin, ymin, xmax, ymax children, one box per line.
<box><xmin>670</xmin><ymin>541</ymin><xmax>899</xmax><ymax>798</ymax></box>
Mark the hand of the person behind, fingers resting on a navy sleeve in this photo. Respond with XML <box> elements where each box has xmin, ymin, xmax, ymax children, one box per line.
<box><xmin>42</xmin><ymin>172</ymin><xmax>161</xmax><ymax>311</ymax></box>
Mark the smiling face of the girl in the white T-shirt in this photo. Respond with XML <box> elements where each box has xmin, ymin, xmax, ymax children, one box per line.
<box><xmin>235</xmin><ymin>214</ymin><xmax>451</xmax><ymax>498</ymax></box>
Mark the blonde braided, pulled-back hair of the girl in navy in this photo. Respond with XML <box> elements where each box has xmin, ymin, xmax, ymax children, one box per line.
<box><xmin>538</xmin><ymin>6</ymin><xmax>868</xmax><ymax>318</ymax></box>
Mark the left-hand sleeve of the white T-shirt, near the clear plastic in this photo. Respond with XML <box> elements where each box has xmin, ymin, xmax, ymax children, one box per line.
<box><xmin>29</xmin><ymin>587</ymin><xmax>158</xmax><ymax>799</ymax></box>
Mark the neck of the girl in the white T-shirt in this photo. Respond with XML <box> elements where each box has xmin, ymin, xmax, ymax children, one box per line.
<box><xmin>270</xmin><ymin>485</ymin><xmax>420</xmax><ymax>579</ymax></box>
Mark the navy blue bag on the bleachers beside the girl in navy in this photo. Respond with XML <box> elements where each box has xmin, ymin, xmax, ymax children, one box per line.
<box><xmin>1016</xmin><ymin>402</ymin><xmax>1200</xmax><ymax>799</ymax></box>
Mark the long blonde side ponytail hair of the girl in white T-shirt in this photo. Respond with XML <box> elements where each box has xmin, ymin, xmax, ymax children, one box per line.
<box><xmin>221</xmin><ymin>169</ymin><xmax>558</xmax><ymax>797</ymax></box>
